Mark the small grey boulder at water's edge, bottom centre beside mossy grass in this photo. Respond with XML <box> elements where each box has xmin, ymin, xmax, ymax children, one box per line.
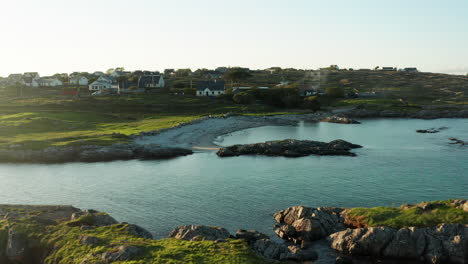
<box><xmin>168</xmin><ymin>225</ymin><xmax>231</xmax><ymax>241</ymax></box>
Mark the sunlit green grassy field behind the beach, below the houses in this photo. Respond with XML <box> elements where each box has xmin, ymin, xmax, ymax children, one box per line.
<box><xmin>0</xmin><ymin>93</ymin><xmax>286</xmax><ymax>149</ymax></box>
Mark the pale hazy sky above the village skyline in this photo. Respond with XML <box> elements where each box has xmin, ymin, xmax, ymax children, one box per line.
<box><xmin>0</xmin><ymin>0</ymin><xmax>468</xmax><ymax>76</ymax></box>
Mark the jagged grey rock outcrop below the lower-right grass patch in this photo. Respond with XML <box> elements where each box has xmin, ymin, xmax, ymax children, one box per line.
<box><xmin>328</xmin><ymin>224</ymin><xmax>468</xmax><ymax>264</ymax></box>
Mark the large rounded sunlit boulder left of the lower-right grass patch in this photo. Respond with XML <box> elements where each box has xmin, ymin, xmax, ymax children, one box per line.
<box><xmin>274</xmin><ymin>206</ymin><xmax>346</xmax><ymax>244</ymax></box>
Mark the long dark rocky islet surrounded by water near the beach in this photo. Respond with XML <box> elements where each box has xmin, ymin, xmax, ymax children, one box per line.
<box><xmin>216</xmin><ymin>139</ymin><xmax>362</xmax><ymax>157</ymax></box>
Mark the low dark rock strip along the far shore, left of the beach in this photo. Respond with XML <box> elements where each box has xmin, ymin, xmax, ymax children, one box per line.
<box><xmin>0</xmin><ymin>144</ymin><xmax>193</xmax><ymax>163</ymax></box>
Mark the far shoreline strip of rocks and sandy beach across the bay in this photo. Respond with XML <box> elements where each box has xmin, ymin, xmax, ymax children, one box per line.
<box><xmin>0</xmin><ymin>107</ymin><xmax>468</xmax><ymax>163</ymax></box>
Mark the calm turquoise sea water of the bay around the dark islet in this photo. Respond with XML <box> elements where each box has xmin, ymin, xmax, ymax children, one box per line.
<box><xmin>0</xmin><ymin>119</ymin><xmax>468</xmax><ymax>237</ymax></box>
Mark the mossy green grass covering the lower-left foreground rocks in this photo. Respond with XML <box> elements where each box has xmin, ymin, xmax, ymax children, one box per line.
<box><xmin>0</xmin><ymin>219</ymin><xmax>269</xmax><ymax>264</ymax></box>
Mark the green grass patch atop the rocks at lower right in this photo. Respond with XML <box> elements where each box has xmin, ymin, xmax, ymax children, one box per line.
<box><xmin>346</xmin><ymin>200</ymin><xmax>468</xmax><ymax>228</ymax></box>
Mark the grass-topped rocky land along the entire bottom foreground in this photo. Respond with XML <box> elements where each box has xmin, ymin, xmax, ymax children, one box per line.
<box><xmin>0</xmin><ymin>199</ymin><xmax>468</xmax><ymax>264</ymax></box>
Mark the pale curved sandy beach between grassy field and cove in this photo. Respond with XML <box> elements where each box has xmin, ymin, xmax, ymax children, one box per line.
<box><xmin>135</xmin><ymin>112</ymin><xmax>329</xmax><ymax>151</ymax></box>
